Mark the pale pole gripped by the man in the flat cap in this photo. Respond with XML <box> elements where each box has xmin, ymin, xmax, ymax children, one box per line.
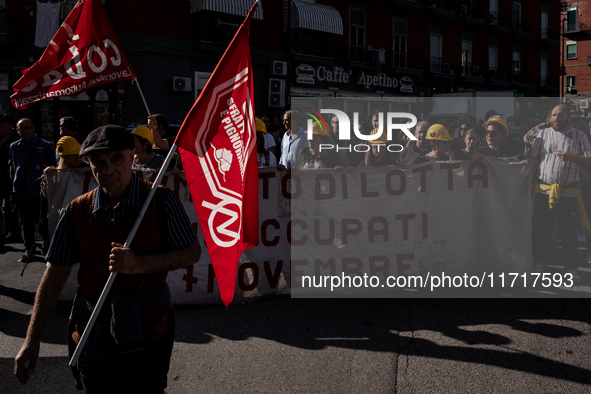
<box><xmin>68</xmin><ymin>143</ymin><xmax>177</xmax><ymax>367</ymax></box>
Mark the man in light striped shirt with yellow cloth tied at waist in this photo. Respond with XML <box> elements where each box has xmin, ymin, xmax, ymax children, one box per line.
<box><xmin>532</xmin><ymin>104</ymin><xmax>591</xmax><ymax>282</ymax></box>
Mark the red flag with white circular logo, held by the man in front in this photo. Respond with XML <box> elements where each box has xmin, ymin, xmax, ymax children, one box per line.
<box><xmin>175</xmin><ymin>3</ymin><xmax>259</xmax><ymax>307</ymax></box>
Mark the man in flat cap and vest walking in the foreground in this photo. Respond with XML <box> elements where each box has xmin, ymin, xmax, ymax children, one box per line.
<box><xmin>14</xmin><ymin>125</ymin><xmax>201</xmax><ymax>393</ymax></box>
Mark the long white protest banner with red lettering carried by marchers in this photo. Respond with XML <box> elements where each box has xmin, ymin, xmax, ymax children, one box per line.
<box><xmin>48</xmin><ymin>159</ymin><xmax>532</xmax><ymax>304</ymax></box>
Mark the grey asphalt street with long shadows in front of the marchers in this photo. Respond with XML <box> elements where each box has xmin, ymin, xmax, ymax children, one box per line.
<box><xmin>0</xmin><ymin>240</ymin><xmax>591</xmax><ymax>394</ymax></box>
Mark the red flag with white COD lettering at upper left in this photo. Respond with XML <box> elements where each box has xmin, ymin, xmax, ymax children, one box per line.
<box><xmin>10</xmin><ymin>0</ymin><xmax>135</xmax><ymax>109</ymax></box>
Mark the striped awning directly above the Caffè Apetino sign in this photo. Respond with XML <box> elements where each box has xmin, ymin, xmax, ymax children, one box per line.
<box><xmin>283</xmin><ymin>0</ymin><xmax>343</xmax><ymax>35</ymax></box>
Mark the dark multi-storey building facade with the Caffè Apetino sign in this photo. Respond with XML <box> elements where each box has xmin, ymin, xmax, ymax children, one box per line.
<box><xmin>0</xmin><ymin>0</ymin><xmax>560</xmax><ymax>139</ymax></box>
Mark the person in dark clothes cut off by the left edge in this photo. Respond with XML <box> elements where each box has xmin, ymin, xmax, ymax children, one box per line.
<box><xmin>0</xmin><ymin>114</ymin><xmax>20</xmax><ymax>252</ymax></box>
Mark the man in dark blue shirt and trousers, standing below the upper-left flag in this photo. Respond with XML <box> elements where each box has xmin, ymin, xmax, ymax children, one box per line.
<box><xmin>9</xmin><ymin>118</ymin><xmax>56</xmax><ymax>263</ymax></box>
